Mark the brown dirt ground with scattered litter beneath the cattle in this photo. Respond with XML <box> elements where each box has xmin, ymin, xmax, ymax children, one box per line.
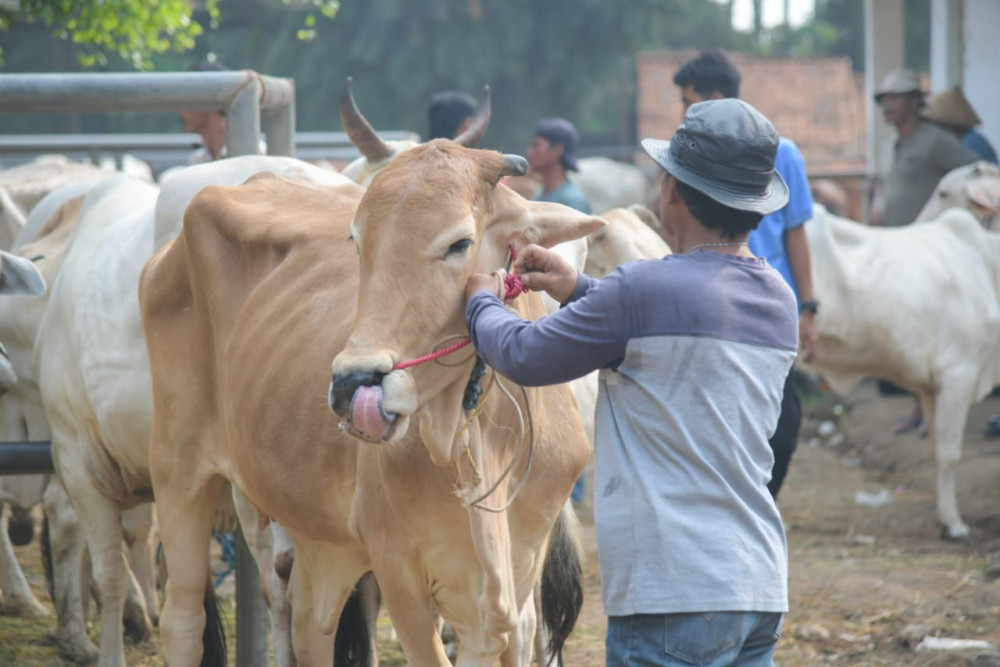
<box><xmin>0</xmin><ymin>383</ymin><xmax>1000</xmax><ymax>667</ymax></box>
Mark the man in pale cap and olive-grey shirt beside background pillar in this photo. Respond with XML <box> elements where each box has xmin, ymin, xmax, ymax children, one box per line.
<box><xmin>875</xmin><ymin>70</ymin><xmax>978</xmax><ymax>227</ymax></box>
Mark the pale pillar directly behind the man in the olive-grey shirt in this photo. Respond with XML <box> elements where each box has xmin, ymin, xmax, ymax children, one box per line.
<box><xmin>863</xmin><ymin>0</ymin><xmax>904</xmax><ymax>220</ymax></box>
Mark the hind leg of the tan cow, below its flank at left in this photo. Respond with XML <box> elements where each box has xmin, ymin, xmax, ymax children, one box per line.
<box><xmin>150</xmin><ymin>474</ymin><xmax>224</xmax><ymax>667</ymax></box>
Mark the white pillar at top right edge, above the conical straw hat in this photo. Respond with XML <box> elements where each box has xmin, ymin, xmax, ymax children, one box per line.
<box><xmin>962</xmin><ymin>0</ymin><xmax>1000</xmax><ymax>150</ymax></box>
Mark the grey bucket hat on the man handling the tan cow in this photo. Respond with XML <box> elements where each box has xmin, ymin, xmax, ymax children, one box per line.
<box><xmin>642</xmin><ymin>98</ymin><xmax>788</xmax><ymax>215</ymax></box>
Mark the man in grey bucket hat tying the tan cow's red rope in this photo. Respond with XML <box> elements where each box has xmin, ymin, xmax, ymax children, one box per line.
<box><xmin>466</xmin><ymin>99</ymin><xmax>798</xmax><ymax>665</ymax></box>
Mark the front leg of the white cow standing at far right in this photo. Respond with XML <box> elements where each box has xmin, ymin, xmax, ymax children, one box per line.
<box><xmin>920</xmin><ymin>382</ymin><xmax>972</xmax><ymax>540</ymax></box>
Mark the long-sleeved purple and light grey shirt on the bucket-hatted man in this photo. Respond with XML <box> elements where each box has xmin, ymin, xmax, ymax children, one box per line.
<box><xmin>466</xmin><ymin>250</ymin><xmax>798</xmax><ymax>616</ymax></box>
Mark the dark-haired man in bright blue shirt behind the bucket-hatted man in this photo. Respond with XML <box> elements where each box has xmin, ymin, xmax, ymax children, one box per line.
<box><xmin>674</xmin><ymin>51</ymin><xmax>819</xmax><ymax>498</ymax></box>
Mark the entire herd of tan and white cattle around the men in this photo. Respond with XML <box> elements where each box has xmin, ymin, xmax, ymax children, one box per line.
<box><xmin>0</xmin><ymin>79</ymin><xmax>1000</xmax><ymax>667</ymax></box>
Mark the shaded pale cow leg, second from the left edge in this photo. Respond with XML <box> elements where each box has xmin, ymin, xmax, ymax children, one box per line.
<box><xmin>43</xmin><ymin>477</ymin><xmax>97</xmax><ymax>664</ymax></box>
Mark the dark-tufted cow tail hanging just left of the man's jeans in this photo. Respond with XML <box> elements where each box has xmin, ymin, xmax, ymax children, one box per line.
<box><xmin>541</xmin><ymin>502</ymin><xmax>583</xmax><ymax>666</ymax></box>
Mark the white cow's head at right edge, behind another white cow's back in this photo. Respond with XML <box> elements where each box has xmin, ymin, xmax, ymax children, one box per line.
<box><xmin>917</xmin><ymin>160</ymin><xmax>1000</xmax><ymax>232</ymax></box>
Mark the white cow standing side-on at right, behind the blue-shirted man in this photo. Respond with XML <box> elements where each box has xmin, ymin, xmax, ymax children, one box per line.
<box><xmin>806</xmin><ymin>206</ymin><xmax>1000</xmax><ymax>539</ymax></box>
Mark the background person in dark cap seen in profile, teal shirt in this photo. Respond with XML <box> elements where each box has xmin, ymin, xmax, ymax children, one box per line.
<box><xmin>528</xmin><ymin>118</ymin><xmax>590</xmax><ymax>213</ymax></box>
